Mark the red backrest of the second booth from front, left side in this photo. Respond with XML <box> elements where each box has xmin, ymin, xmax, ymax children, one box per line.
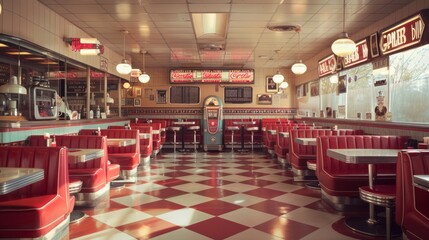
<box><xmin>27</xmin><ymin>135</ymin><xmax>108</xmax><ymax>172</ymax></box>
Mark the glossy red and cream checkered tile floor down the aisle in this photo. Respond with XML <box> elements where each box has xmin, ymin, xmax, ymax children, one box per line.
<box><xmin>69</xmin><ymin>152</ymin><xmax>402</xmax><ymax>240</ymax></box>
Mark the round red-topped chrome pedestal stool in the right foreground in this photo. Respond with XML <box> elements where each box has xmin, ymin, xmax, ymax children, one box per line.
<box><xmin>359</xmin><ymin>184</ymin><xmax>401</xmax><ymax>239</ymax></box>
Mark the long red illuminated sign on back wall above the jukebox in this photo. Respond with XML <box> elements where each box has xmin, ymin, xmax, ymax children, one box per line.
<box><xmin>170</xmin><ymin>69</ymin><xmax>255</xmax><ymax>84</ymax></box>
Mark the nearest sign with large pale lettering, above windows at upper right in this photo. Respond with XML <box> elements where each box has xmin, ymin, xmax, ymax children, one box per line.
<box><xmin>380</xmin><ymin>11</ymin><xmax>427</xmax><ymax>54</ymax></box>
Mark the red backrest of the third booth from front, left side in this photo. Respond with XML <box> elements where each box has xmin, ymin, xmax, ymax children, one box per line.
<box><xmin>79</xmin><ymin>129</ymin><xmax>140</xmax><ymax>154</ymax></box>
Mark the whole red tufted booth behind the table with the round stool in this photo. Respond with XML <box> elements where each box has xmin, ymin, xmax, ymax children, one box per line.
<box><xmin>316</xmin><ymin>135</ymin><xmax>408</xmax><ymax>197</ymax></box>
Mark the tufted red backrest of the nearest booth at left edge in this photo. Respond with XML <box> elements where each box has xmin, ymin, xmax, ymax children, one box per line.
<box><xmin>0</xmin><ymin>146</ymin><xmax>70</xmax><ymax>201</ymax></box>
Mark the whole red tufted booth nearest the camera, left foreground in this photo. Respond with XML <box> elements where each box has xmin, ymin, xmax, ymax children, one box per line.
<box><xmin>0</xmin><ymin>146</ymin><xmax>74</xmax><ymax>238</ymax></box>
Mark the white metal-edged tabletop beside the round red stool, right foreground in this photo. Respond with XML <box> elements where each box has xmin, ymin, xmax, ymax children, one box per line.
<box><xmin>327</xmin><ymin>148</ymin><xmax>399</xmax><ymax>163</ymax></box>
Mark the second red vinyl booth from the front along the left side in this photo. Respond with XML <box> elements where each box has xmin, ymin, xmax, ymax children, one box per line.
<box><xmin>27</xmin><ymin>135</ymin><xmax>120</xmax><ymax>206</ymax></box>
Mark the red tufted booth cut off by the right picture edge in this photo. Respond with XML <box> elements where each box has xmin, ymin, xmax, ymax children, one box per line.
<box><xmin>396</xmin><ymin>150</ymin><xmax>429</xmax><ymax>239</ymax></box>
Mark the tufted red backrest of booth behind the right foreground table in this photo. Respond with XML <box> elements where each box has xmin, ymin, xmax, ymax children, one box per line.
<box><xmin>317</xmin><ymin>135</ymin><xmax>408</xmax><ymax>174</ymax></box>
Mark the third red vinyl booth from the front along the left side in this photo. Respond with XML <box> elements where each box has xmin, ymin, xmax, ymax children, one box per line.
<box><xmin>79</xmin><ymin>129</ymin><xmax>140</xmax><ymax>182</ymax></box>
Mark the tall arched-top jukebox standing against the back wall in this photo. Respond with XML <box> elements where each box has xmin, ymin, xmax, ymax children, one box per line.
<box><xmin>203</xmin><ymin>96</ymin><xmax>223</xmax><ymax>151</ymax></box>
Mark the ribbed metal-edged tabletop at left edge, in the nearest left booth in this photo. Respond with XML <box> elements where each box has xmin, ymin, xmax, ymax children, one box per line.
<box><xmin>0</xmin><ymin>167</ymin><xmax>44</xmax><ymax>195</ymax></box>
